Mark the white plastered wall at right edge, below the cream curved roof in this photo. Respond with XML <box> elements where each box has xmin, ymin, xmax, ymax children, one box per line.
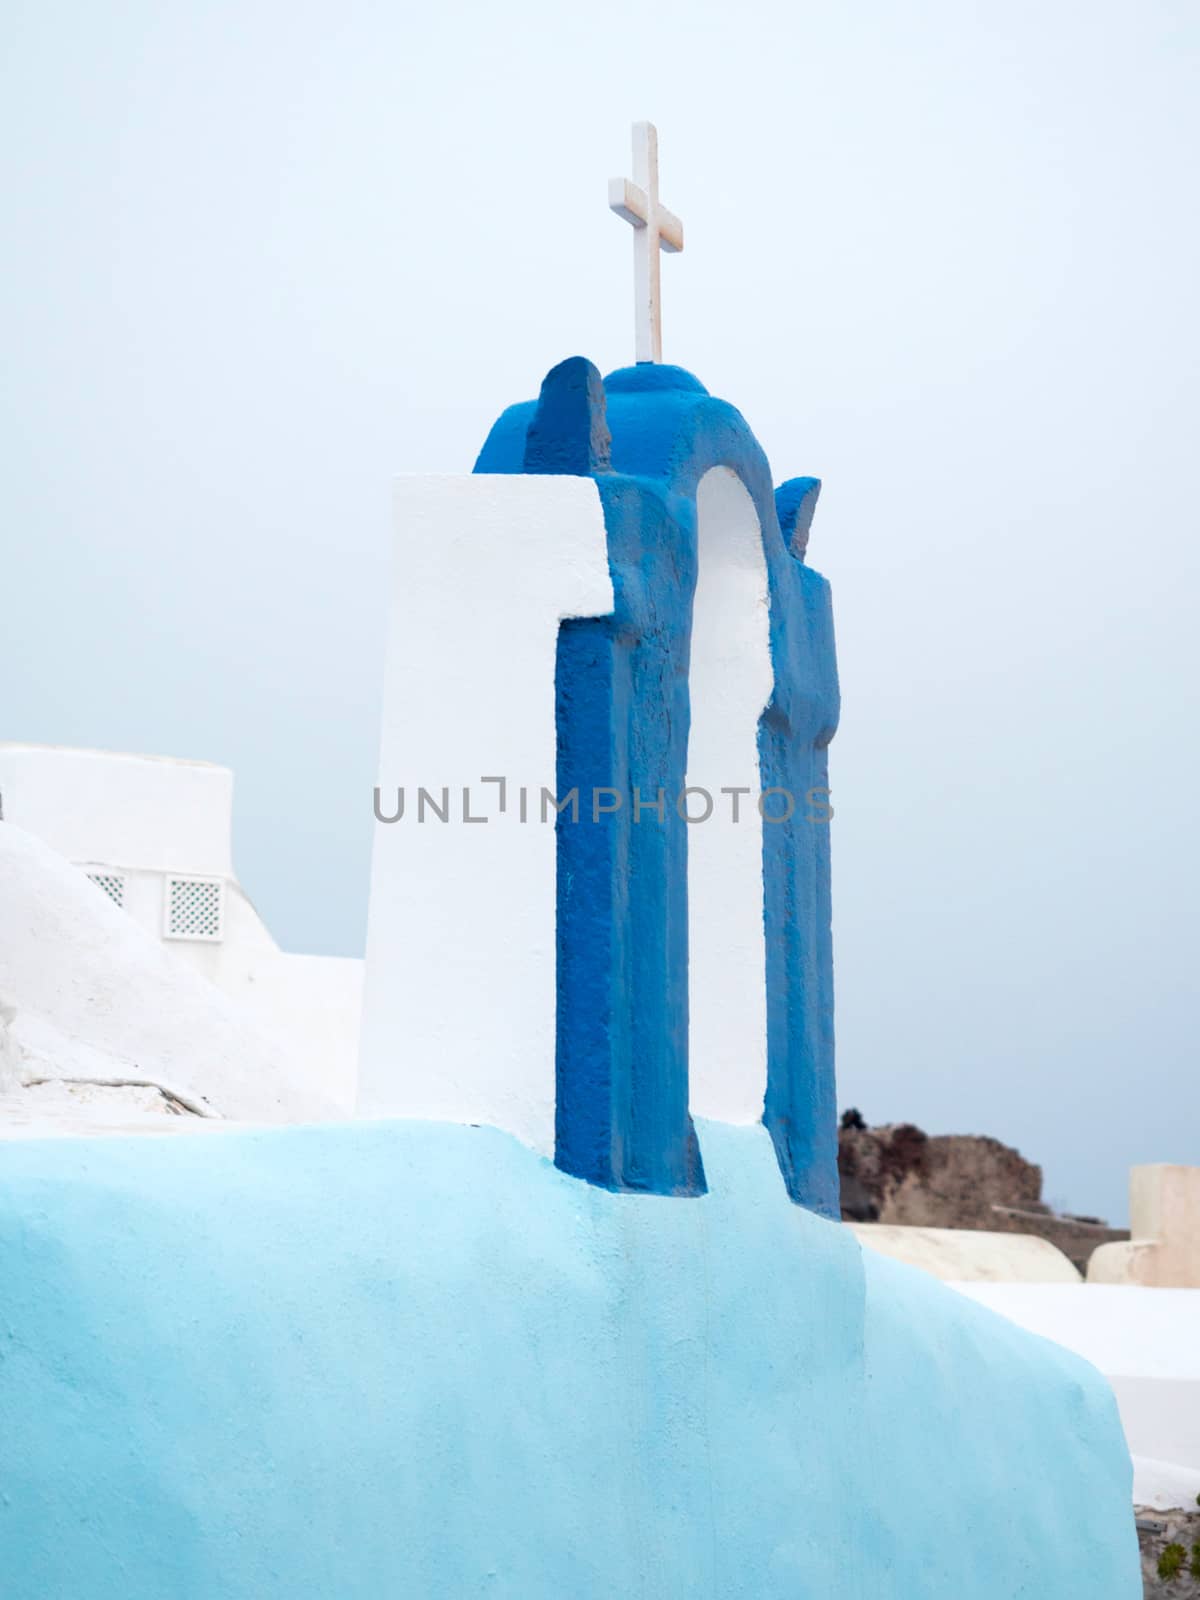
<box><xmin>955</xmin><ymin>1283</ymin><xmax>1200</xmax><ymax>1472</ymax></box>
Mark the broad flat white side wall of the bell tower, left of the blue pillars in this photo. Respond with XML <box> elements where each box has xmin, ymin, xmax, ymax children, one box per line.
<box><xmin>358</xmin><ymin>475</ymin><xmax>613</xmax><ymax>1154</ymax></box>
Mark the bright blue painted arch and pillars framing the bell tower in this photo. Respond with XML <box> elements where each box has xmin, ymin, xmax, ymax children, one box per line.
<box><xmin>475</xmin><ymin>357</ymin><xmax>838</xmax><ymax>1216</ymax></box>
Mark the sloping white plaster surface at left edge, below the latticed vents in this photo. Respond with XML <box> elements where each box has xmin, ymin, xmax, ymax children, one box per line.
<box><xmin>0</xmin><ymin>822</ymin><xmax>336</xmax><ymax>1126</ymax></box>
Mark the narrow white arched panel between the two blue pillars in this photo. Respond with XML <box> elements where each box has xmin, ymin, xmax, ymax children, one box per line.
<box><xmin>688</xmin><ymin>467</ymin><xmax>779</xmax><ymax>1123</ymax></box>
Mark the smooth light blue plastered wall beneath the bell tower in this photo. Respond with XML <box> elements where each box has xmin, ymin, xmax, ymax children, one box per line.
<box><xmin>0</xmin><ymin>1123</ymin><xmax>1141</xmax><ymax>1600</ymax></box>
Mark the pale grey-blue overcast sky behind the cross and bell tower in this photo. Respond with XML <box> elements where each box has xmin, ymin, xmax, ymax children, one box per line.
<box><xmin>0</xmin><ymin>0</ymin><xmax>1200</xmax><ymax>1216</ymax></box>
